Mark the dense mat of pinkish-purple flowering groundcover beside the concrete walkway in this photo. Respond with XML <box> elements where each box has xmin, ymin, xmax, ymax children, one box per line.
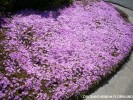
<box><xmin>0</xmin><ymin>0</ymin><xmax>133</xmax><ymax>100</ymax></box>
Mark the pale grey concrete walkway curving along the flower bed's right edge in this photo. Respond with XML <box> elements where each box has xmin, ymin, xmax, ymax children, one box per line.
<box><xmin>85</xmin><ymin>5</ymin><xmax>133</xmax><ymax>100</ymax></box>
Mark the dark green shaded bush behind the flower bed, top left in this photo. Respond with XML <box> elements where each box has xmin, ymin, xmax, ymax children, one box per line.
<box><xmin>0</xmin><ymin>0</ymin><xmax>72</xmax><ymax>13</ymax></box>
